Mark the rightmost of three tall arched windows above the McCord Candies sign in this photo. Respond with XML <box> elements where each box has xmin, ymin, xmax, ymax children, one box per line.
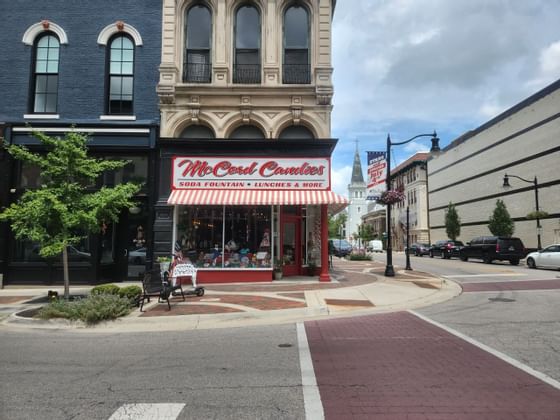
<box><xmin>282</xmin><ymin>4</ymin><xmax>311</xmax><ymax>84</ymax></box>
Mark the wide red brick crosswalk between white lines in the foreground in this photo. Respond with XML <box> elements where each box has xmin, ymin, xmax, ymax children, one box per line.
<box><xmin>305</xmin><ymin>312</ymin><xmax>560</xmax><ymax>420</ymax></box>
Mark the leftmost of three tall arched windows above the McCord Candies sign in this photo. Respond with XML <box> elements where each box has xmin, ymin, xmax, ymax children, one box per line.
<box><xmin>183</xmin><ymin>4</ymin><xmax>212</xmax><ymax>83</ymax></box>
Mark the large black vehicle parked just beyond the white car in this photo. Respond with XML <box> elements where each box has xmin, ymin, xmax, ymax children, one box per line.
<box><xmin>460</xmin><ymin>236</ymin><xmax>527</xmax><ymax>265</ymax></box>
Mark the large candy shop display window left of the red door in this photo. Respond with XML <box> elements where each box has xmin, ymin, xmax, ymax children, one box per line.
<box><xmin>177</xmin><ymin>206</ymin><xmax>272</xmax><ymax>268</ymax></box>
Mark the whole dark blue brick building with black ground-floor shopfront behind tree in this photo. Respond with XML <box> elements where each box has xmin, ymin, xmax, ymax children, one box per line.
<box><xmin>0</xmin><ymin>0</ymin><xmax>162</xmax><ymax>284</ymax></box>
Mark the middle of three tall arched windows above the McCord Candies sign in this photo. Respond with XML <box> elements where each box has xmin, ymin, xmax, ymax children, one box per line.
<box><xmin>233</xmin><ymin>5</ymin><xmax>261</xmax><ymax>83</ymax></box>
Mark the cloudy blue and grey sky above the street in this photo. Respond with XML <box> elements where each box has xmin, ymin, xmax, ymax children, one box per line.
<box><xmin>331</xmin><ymin>0</ymin><xmax>560</xmax><ymax>195</ymax></box>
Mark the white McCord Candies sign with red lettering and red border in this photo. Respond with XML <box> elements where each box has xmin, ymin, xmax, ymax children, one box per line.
<box><xmin>172</xmin><ymin>156</ymin><xmax>330</xmax><ymax>190</ymax></box>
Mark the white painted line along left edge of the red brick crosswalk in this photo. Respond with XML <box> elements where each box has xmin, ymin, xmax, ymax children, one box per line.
<box><xmin>296</xmin><ymin>322</ymin><xmax>325</xmax><ymax>420</ymax></box>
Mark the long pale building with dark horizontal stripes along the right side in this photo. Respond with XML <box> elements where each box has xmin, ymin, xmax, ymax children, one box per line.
<box><xmin>428</xmin><ymin>80</ymin><xmax>560</xmax><ymax>248</ymax></box>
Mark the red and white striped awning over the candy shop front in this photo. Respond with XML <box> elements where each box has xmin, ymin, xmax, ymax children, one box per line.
<box><xmin>167</xmin><ymin>189</ymin><xmax>348</xmax><ymax>214</ymax></box>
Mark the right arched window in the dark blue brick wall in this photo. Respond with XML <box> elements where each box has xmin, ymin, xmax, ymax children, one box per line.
<box><xmin>106</xmin><ymin>34</ymin><xmax>134</xmax><ymax>115</ymax></box>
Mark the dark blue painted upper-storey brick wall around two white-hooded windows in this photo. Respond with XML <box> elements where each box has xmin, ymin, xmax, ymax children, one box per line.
<box><xmin>0</xmin><ymin>0</ymin><xmax>161</xmax><ymax>122</ymax></box>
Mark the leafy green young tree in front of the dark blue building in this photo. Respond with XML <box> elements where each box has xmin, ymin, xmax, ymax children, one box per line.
<box><xmin>0</xmin><ymin>131</ymin><xmax>141</xmax><ymax>299</ymax></box>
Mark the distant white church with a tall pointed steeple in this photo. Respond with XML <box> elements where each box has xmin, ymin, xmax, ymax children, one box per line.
<box><xmin>345</xmin><ymin>144</ymin><xmax>368</xmax><ymax>245</ymax></box>
